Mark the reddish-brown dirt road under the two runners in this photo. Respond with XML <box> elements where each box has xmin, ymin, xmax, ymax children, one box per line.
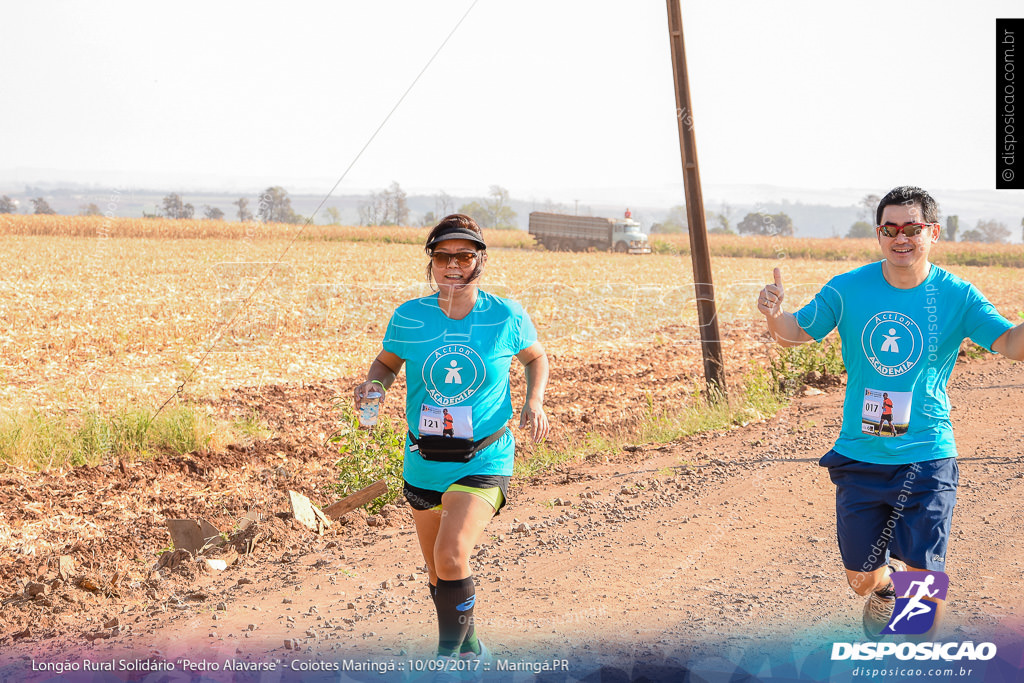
<box><xmin>0</xmin><ymin>359</ymin><xmax>1024</xmax><ymax>680</ymax></box>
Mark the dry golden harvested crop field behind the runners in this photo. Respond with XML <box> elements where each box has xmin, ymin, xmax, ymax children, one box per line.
<box><xmin>0</xmin><ymin>216</ymin><xmax>1024</xmax><ymax>454</ymax></box>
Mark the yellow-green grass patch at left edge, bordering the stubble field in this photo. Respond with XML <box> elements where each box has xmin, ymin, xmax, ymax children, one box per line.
<box><xmin>0</xmin><ymin>404</ymin><xmax>236</xmax><ymax>471</ymax></box>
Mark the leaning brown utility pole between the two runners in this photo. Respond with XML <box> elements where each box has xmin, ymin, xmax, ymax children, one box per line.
<box><xmin>667</xmin><ymin>0</ymin><xmax>726</xmax><ymax>398</ymax></box>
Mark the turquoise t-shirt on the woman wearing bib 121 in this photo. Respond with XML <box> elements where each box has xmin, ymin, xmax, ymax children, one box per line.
<box><xmin>384</xmin><ymin>291</ymin><xmax>537</xmax><ymax>492</ymax></box>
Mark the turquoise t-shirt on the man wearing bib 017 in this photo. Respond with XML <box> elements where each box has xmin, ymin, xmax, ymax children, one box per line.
<box><xmin>796</xmin><ymin>261</ymin><xmax>1013</xmax><ymax>465</ymax></box>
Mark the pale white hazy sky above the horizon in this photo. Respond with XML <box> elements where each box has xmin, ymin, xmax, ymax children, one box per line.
<box><xmin>0</xmin><ymin>0</ymin><xmax>1022</xmax><ymax>201</ymax></box>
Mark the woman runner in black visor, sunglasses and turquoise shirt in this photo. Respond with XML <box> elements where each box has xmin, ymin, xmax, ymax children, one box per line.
<box><xmin>355</xmin><ymin>214</ymin><xmax>549</xmax><ymax>658</ymax></box>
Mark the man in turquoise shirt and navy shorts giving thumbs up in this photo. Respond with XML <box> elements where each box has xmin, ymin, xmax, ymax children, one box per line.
<box><xmin>758</xmin><ymin>186</ymin><xmax>1024</xmax><ymax>640</ymax></box>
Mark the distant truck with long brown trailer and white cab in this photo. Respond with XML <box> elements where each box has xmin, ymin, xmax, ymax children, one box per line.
<box><xmin>529</xmin><ymin>209</ymin><xmax>650</xmax><ymax>254</ymax></box>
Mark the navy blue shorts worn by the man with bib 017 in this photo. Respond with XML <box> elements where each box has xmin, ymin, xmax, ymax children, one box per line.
<box><xmin>818</xmin><ymin>451</ymin><xmax>959</xmax><ymax>571</ymax></box>
